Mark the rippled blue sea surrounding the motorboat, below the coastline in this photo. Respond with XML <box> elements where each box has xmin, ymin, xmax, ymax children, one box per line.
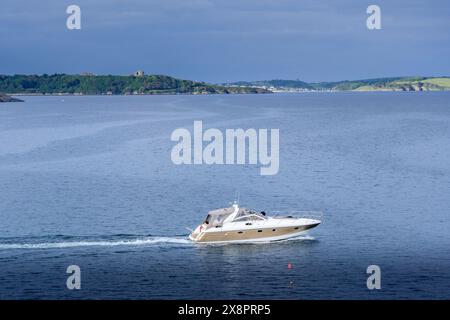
<box><xmin>0</xmin><ymin>93</ymin><xmax>450</xmax><ymax>299</ymax></box>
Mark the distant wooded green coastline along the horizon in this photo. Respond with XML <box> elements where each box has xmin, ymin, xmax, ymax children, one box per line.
<box><xmin>0</xmin><ymin>71</ymin><xmax>450</xmax><ymax>98</ymax></box>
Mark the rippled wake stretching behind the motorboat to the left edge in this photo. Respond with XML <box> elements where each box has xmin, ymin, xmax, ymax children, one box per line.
<box><xmin>0</xmin><ymin>236</ymin><xmax>192</xmax><ymax>250</ymax></box>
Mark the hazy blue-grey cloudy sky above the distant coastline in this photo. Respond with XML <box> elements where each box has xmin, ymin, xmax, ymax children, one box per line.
<box><xmin>0</xmin><ymin>0</ymin><xmax>450</xmax><ymax>83</ymax></box>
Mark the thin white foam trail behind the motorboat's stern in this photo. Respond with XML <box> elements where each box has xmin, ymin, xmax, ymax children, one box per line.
<box><xmin>0</xmin><ymin>237</ymin><xmax>191</xmax><ymax>250</ymax></box>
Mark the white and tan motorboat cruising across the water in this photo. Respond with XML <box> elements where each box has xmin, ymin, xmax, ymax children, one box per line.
<box><xmin>189</xmin><ymin>201</ymin><xmax>322</xmax><ymax>243</ymax></box>
